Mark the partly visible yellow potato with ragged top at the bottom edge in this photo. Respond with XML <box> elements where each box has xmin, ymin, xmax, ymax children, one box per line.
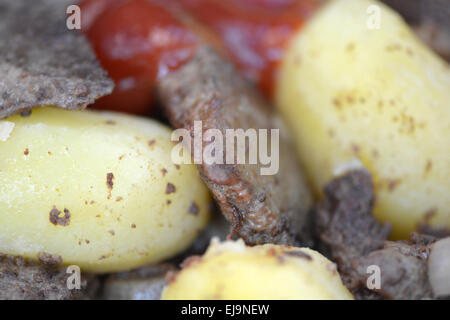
<box><xmin>162</xmin><ymin>239</ymin><xmax>353</xmax><ymax>300</ymax></box>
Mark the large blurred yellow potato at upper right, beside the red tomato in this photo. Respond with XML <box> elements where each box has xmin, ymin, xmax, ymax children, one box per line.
<box><xmin>277</xmin><ymin>0</ymin><xmax>450</xmax><ymax>238</ymax></box>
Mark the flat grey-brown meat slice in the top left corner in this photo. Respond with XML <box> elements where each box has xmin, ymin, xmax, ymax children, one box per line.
<box><xmin>0</xmin><ymin>0</ymin><xmax>113</xmax><ymax>119</ymax></box>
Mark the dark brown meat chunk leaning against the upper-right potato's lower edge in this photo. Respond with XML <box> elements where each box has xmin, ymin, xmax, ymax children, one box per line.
<box><xmin>316</xmin><ymin>170</ymin><xmax>391</xmax><ymax>289</ymax></box>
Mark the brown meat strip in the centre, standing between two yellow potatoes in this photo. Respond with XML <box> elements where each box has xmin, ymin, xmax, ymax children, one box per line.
<box><xmin>157</xmin><ymin>48</ymin><xmax>311</xmax><ymax>245</ymax></box>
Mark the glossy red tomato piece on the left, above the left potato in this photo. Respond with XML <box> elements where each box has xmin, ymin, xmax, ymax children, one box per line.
<box><xmin>81</xmin><ymin>0</ymin><xmax>199</xmax><ymax>115</ymax></box>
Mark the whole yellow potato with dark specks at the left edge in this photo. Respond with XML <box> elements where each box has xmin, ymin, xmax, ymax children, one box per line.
<box><xmin>0</xmin><ymin>107</ymin><xmax>210</xmax><ymax>272</ymax></box>
